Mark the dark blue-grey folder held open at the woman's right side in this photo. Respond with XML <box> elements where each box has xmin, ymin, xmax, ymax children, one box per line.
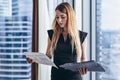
<box><xmin>60</xmin><ymin>60</ymin><xmax>105</xmax><ymax>72</ymax></box>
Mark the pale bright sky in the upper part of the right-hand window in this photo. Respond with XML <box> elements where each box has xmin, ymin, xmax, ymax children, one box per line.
<box><xmin>101</xmin><ymin>0</ymin><xmax>120</xmax><ymax>30</ymax></box>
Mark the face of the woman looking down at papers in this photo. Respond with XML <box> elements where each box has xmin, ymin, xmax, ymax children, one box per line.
<box><xmin>56</xmin><ymin>10</ymin><xmax>67</xmax><ymax>28</ymax></box>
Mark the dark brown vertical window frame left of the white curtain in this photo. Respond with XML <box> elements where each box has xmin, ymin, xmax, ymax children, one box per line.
<box><xmin>31</xmin><ymin>0</ymin><xmax>39</xmax><ymax>80</ymax></box>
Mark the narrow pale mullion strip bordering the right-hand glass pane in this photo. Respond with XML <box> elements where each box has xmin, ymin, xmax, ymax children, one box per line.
<box><xmin>90</xmin><ymin>0</ymin><xmax>97</xmax><ymax>80</ymax></box>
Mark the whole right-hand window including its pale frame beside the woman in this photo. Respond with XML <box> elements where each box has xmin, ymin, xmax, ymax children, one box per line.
<box><xmin>82</xmin><ymin>0</ymin><xmax>120</xmax><ymax>80</ymax></box>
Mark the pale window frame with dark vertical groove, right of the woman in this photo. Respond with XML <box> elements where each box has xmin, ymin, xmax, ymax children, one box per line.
<box><xmin>82</xmin><ymin>0</ymin><xmax>96</xmax><ymax>80</ymax></box>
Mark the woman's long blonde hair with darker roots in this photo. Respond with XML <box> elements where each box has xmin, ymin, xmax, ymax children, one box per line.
<box><xmin>50</xmin><ymin>2</ymin><xmax>81</xmax><ymax>59</ymax></box>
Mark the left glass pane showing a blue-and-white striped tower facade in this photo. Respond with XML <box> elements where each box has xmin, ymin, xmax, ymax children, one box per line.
<box><xmin>0</xmin><ymin>0</ymin><xmax>32</xmax><ymax>80</ymax></box>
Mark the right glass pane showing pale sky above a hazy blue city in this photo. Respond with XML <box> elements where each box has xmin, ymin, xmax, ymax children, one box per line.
<box><xmin>96</xmin><ymin>0</ymin><xmax>120</xmax><ymax>80</ymax></box>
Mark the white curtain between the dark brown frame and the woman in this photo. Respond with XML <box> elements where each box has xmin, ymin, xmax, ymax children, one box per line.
<box><xmin>38</xmin><ymin>0</ymin><xmax>73</xmax><ymax>80</ymax></box>
